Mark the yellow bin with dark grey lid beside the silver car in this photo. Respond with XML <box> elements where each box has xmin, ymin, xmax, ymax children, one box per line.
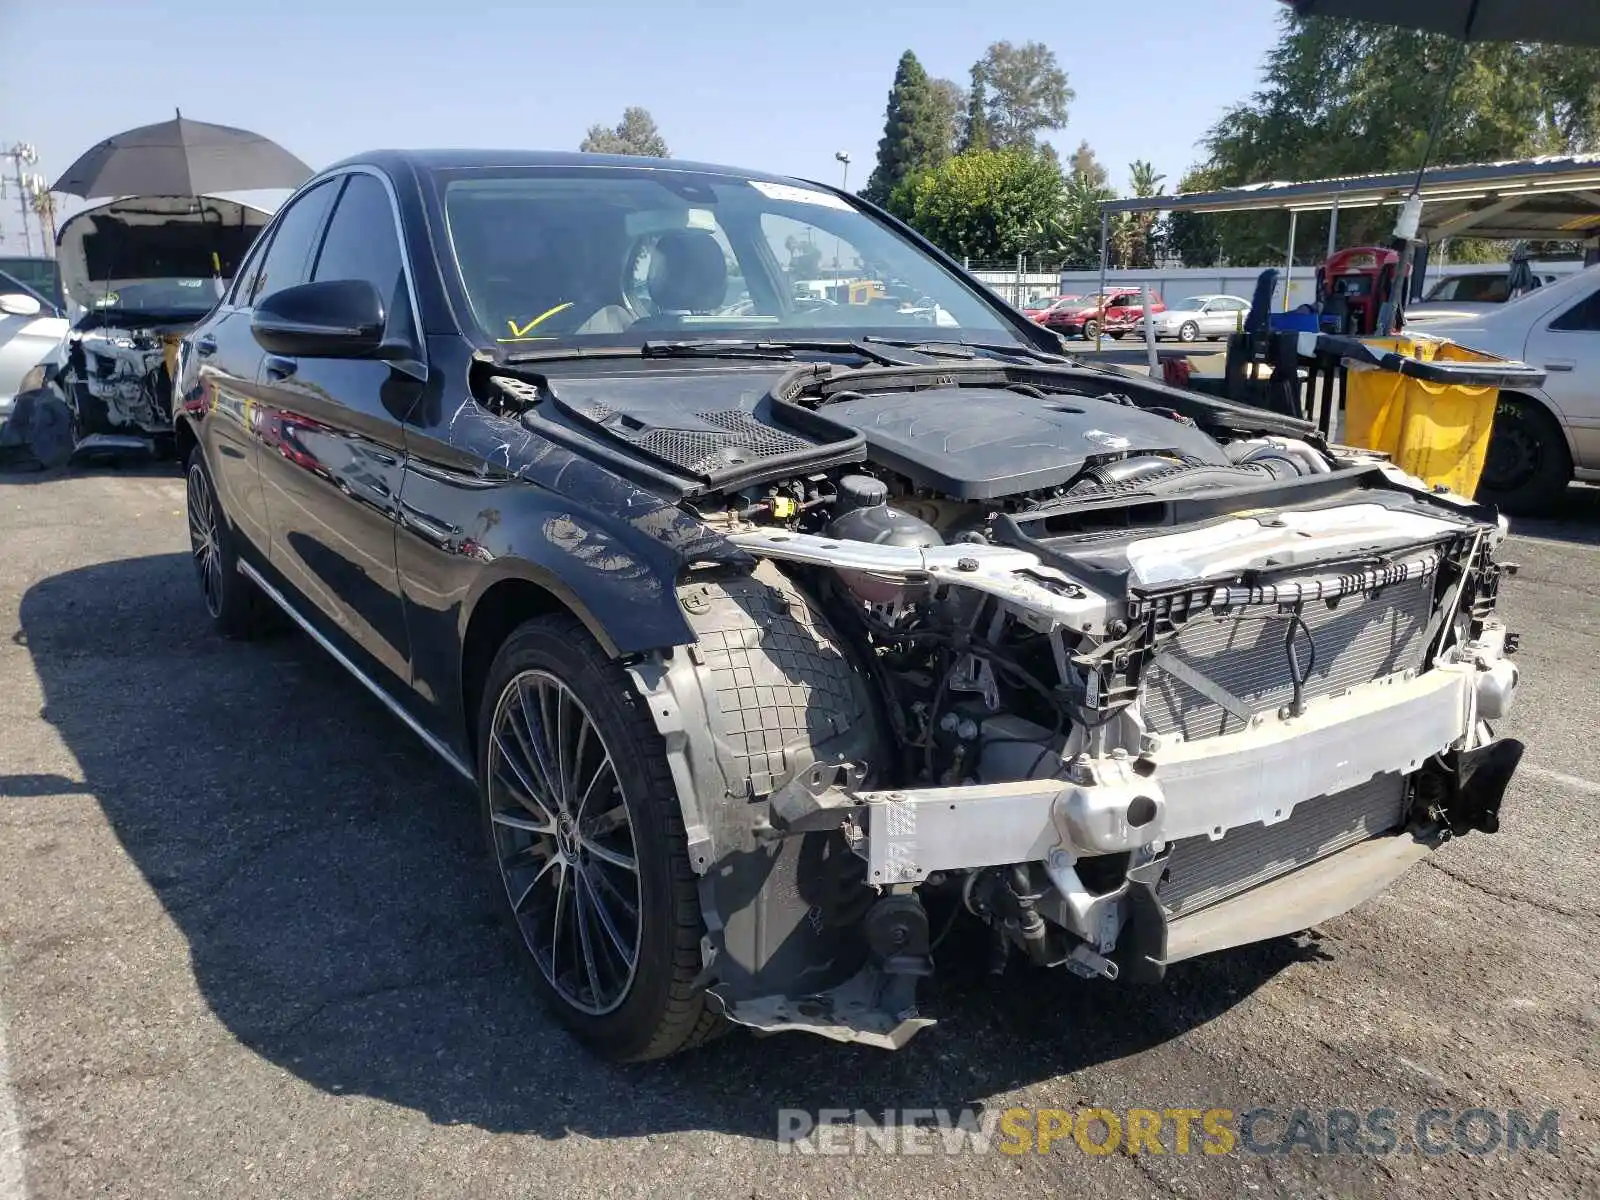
<box><xmin>1318</xmin><ymin>333</ymin><xmax>1544</xmax><ymax>496</ymax></box>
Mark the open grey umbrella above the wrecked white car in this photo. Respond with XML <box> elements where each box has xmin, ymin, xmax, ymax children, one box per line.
<box><xmin>50</xmin><ymin>110</ymin><xmax>310</xmax><ymax>200</ymax></box>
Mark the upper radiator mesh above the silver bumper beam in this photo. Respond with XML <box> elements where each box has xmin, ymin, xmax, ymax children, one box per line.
<box><xmin>1139</xmin><ymin>576</ymin><xmax>1434</xmax><ymax>741</ymax></box>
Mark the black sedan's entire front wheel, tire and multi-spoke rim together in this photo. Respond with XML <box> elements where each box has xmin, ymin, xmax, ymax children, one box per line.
<box><xmin>477</xmin><ymin>614</ymin><xmax>722</xmax><ymax>1062</ymax></box>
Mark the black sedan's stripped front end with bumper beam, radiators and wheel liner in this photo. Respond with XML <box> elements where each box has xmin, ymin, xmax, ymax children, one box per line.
<box><xmin>630</xmin><ymin>473</ymin><xmax>1522</xmax><ymax>1048</ymax></box>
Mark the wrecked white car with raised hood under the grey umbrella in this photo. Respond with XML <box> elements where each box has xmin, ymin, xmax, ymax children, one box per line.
<box><xmin>0</xmin><ymin>195</ymin><xmax>270</xmax><ymax>466</ymax></box>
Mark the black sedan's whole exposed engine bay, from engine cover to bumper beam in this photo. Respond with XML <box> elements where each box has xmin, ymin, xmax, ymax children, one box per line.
<box><xmin>491</xmin><ymin>352</ymin><xmax>1522</xmax><ymax>1046</ymax></box>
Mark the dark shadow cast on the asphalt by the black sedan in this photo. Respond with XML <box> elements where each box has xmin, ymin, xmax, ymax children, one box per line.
<box><xmin>21</xmin><ymin>554</ymin><xmax>1317</xmax><ymax>1139</ymax></box>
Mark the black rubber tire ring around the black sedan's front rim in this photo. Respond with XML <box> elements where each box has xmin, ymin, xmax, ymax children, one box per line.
<box><xmin>477</xmin><ymin>618</ymin><xmax>688</xmax><ymax>1059</ymax></box>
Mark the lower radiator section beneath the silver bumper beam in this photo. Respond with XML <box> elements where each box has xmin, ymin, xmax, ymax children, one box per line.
<box><xmin>1157</xmin><ymin>774</ymin><xmax>1406</xmax><ymax>915</ymax></box>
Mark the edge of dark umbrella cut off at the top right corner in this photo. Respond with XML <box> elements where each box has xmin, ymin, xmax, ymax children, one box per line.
<box><xmin>1283</xmin><ymin>0</ymin><xmax>1600</xmax><ymax>46</ymax></box>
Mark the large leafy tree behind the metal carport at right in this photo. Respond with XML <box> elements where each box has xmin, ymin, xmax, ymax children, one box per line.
<box><xmin>1173</xmin><ymin>14</ymin><xmax>1600</xmax><ymax>266</ymax></box>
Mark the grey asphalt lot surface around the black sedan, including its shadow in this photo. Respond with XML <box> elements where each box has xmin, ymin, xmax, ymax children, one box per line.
<box><xmin>0</xmin><ymin>469</ymin><xmax>1600</xmax><ymax>1200</ymax></box>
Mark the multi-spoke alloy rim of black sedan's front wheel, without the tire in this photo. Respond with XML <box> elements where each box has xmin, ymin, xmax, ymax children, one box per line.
<box><xmin>485</xmin><ymin>670</ymin><xmax>642</xmax><ymax>1016</ymax></box>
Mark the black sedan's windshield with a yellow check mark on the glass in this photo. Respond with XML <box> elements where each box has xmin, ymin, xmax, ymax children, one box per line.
<box><xmin>437</xmin><ymin>166</ymin><xmax>1016</xmax><ymax>350</ymax></box>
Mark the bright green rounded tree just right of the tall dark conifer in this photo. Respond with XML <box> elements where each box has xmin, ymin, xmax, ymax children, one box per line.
<box><xmin>890</xmin><ymin>150</ymin><xmax>1062</xmax><ymax>259</ymax></box>
